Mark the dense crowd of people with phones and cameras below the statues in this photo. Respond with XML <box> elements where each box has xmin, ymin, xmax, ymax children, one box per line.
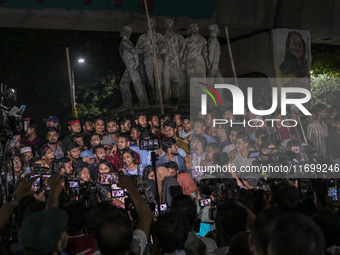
<box><xmin>0</xmin><ymin>104</ymin><xmax>340</xmax><ymax>255</ymax></box>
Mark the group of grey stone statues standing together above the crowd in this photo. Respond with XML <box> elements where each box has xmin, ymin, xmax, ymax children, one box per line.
<box><xmin>119</xmin><ymin>19</ymin><xmax>222</xmax><ymax>108</ymax></box>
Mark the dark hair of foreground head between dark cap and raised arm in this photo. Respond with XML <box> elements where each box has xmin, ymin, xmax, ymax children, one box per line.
<box><xmin>94</xmin><ymin>203</ymin><xmax>133</xmax><ymax>255</ymax></box>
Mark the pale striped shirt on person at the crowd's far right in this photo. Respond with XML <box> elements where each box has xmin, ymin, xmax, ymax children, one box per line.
<box><xmin>307</xmin><ymin>120</ymin><xmax>329</xmax><ymax>159</ymax></box>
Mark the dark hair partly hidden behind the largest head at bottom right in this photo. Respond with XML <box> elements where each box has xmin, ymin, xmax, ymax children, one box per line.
<box><xmin>253</xmin><ymin>207</ymin><xmax>284</xmax><ymax>255</ymax></box>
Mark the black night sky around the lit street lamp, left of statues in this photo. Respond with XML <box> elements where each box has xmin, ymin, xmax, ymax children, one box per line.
<box><xmin>0</xmin><ymin>28</ymin><xmax>124</xmax><ymax>133</ymax></box>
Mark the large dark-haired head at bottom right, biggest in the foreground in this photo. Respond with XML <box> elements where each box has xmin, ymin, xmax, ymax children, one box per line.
<box><xmin>269</xmin><ymin>213</ymin><xmax>325</xmax><ymax>255</ymax></box>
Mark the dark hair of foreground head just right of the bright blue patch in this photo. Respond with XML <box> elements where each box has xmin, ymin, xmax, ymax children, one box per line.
<box><xmin>215</xmin><ymin>201</ymin><xmax>248</xmax><ymax>243</ymax></box>
